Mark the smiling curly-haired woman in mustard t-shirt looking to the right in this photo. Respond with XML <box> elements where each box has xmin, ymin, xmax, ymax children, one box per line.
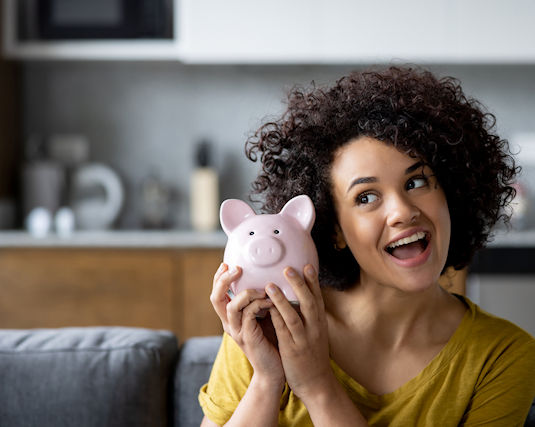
<box><xmin>200</xmin><ymin>67</ymin><xmax>535</xmax><ymax>426</ymax></box>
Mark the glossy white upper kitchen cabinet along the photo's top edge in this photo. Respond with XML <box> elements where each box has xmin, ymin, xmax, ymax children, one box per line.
<box><xmin>4</xmin><ymin>0</ymin><xmax>535</xmax><ymax>64</ymax></box>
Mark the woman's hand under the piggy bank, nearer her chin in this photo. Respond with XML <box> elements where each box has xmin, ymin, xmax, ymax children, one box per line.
<box><xmin>266</xmin><ymin>265</ymin><xmax>336</xmax><ymax>405</ymax></box>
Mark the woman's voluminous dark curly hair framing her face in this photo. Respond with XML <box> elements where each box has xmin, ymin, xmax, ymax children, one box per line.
<box><xmin>245</xmin><ymin>67</ymin><xmax>519</xmax><ymax>290</ymax></box>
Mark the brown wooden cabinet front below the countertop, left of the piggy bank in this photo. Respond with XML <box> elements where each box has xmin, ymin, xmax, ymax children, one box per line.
<box><xmin>0</xmin><ymin>248</ymin><xmax>223</xmax><ymax>341</ymax></box>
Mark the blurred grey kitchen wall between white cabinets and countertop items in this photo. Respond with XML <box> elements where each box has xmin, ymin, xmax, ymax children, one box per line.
<box><xmin>24</xmin><ymin>61</ymin><xmax>535</xmax><ymax>228</ymax></box>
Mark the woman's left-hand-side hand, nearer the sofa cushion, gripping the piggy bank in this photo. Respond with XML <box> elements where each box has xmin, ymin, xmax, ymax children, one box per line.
<box><xmin>210</xmin><ymin>263</ymin><xmax>284</xmax><ymax>391</ymax></box>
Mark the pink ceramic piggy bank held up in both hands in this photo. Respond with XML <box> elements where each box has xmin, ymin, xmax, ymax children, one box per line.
<box><xmin>220</xmin><ymin>195</ymin><xmax>318</xmax><ymax>303</ymax></box>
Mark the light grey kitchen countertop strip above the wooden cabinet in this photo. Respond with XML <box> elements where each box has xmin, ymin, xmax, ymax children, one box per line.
<box><xmin>0</xmin><ymin>230</ymin><xmax>535</xmax><ymax>249</ymax></box>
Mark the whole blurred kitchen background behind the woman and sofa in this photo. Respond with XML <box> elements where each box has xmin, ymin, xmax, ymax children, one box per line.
<box><xmin>0</xmin><ymin>0</ymin><xmax>535</xmax><ymax>337</ymax></box>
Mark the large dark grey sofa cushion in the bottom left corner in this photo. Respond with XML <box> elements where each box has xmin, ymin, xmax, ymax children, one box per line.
<box><xmin>0</xmin><ymin>327</ymin><xmax>178</xmax><ymax>427</ymax></box>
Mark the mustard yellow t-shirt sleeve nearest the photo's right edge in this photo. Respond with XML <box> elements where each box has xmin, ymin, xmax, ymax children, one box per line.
<box><xmin>461</xmin><ymin>331</ymin><xmax>535</xmax><ymax>426</ymax></box>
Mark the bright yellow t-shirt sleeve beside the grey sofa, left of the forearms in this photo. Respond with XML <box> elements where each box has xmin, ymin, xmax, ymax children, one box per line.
<box><xmin>199</xmin><ymin>333</ymin><xmax>253</xmax><ymax>425</ymax></box>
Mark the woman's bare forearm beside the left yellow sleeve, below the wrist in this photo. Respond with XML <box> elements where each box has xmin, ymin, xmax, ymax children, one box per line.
<box><xmin>225</xmin><ymin>374</ymin><xmax>284</xmax><ymax>427</ymax></box>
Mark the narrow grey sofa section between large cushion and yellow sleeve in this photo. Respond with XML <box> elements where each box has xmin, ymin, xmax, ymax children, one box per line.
<box><xmin>174</xmin><ymin>336</ymin><xmax>221</xmax><ymax>427</ymax></box>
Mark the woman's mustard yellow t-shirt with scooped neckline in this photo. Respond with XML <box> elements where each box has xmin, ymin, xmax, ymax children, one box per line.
<box><xmin>199</xmin><ymin>297</ymin><xmax>535</xmax><ymax>427</ymax></box>
